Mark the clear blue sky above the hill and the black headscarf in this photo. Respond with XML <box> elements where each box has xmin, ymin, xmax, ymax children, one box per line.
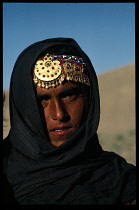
<box><xmin>3</xmin><ymin>2</ymin><xmax>135</xmax><ymax>89</ymax></box>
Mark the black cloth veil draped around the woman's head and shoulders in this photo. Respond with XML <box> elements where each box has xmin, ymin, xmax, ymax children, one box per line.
<box><xmin>4</xmin><ymin>38</ymin><xmax>136</xmax><ymax>205</ymax></box>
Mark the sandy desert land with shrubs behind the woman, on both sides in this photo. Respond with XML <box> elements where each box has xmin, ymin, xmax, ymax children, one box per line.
<box><xmin>3</xmin><ymin>63</ymin><xmax>136</xmax><ymax>165</ymax></box>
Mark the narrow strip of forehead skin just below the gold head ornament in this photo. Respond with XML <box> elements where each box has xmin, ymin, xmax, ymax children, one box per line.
<box><xmin>36</xmin><ymin>81</ymin><xmax>80</xmax><ymax>95</ymax></box>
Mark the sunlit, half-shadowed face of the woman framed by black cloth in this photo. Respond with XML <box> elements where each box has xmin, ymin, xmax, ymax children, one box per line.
<box><xmin>37</xmin><ymin>82</ymin><xmax>85</xmax><ymax>146</ymax></box>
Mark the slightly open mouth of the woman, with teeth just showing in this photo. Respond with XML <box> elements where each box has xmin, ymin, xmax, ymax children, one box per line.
<box><xmin>50</xmin><ymin>127</ymin><xmax>73</xmax><ymax>136</ymax></box>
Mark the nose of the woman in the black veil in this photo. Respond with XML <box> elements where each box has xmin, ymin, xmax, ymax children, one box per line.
<box><xmin>50</xmin><ymin>99</ymin><xmax>70</xmax><ymax>122</ymax></box>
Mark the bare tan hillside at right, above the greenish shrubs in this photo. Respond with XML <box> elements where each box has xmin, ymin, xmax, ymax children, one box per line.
<box><xmin>98</xmin><ymin>64</ymin><xmax>135</xmax><ymax>132</ymax></box>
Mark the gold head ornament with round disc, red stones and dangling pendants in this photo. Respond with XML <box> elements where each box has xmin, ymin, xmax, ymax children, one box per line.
<box><xmin>33</xmin><ymin>54</ymin><xmax>90</xmax><ymax>89</ymax></box>
